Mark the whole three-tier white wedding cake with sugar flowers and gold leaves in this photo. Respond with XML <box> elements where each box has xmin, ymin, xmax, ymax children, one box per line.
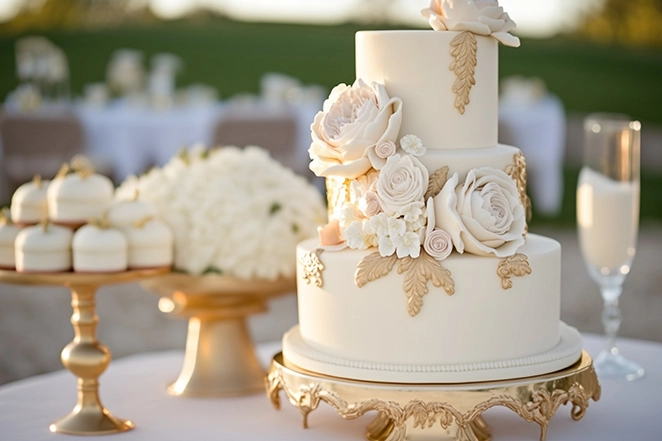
<box><xmin>283</xmin><ymin>0</ymin><xmax>582</xmax><ymax>383</ymax></box>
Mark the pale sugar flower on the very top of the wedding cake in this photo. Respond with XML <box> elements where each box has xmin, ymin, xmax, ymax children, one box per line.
<box><xmin>421</xmin><ymin>0</ymin><xmax>520</xmax><ymax>47</ymax></box>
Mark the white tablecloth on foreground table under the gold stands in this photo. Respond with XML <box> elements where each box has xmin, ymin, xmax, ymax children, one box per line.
<box><xmin>0</xmin><ymin>335</ymin><xmax>662</xmax><ymax>441</ymax></box>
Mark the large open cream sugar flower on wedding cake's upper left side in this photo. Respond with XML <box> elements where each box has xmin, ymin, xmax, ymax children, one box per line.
<box><xmin>308</xmin><ymin>79</ymin><xmax>402</xmax><ymax>179</ymax></box>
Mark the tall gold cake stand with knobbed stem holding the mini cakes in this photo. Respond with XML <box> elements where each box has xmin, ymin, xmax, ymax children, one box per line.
<box><xmin>0</xmin><ymin>268</ymin><xmax>169</xmax><ymax>435</ymax></box>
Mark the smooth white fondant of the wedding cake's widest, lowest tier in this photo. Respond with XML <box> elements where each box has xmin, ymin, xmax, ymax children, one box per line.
<box><xmin>297</xmin><ymin>234</ymin><xmax>561</xmax><ymax>365</ymax></box>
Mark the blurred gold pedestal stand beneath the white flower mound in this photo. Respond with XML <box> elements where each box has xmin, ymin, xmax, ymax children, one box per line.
<box><xmin>142</xmin><ymin>273</ymin><xmax>295</xmax><ymax>397</ymax></box>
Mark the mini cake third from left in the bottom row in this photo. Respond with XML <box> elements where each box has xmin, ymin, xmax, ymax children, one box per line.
<box><xmin>72</xmin><ymin>221</ymin><xmax>128</xmax><ymax>273</ymax></box>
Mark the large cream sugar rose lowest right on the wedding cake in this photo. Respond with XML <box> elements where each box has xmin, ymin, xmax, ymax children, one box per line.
<box><xmin>434</xmin><ymin>167</ymin><xmax>526</xmax><ymax>257</ymax></box>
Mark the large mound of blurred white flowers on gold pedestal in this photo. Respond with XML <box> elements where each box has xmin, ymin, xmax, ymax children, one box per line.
<box><xmin>116</xmin><ymin>146</ymin><xmax>326</xmax><ymax>280</ymax></box>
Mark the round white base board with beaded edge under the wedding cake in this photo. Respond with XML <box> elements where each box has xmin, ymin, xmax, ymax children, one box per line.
<box><xmin>283</xmin><ymin>322</ymin><xmax>582</xmax><ymax>384</ymax></box>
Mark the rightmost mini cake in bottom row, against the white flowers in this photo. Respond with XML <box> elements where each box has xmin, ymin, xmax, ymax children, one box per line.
<box><xmin>124</xmin><ymin>218</ymin><xmax>174</xmax><ymax>269</ymax></box>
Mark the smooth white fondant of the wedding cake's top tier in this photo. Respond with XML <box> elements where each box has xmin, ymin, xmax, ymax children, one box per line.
<box><xmin>356</xmin><ymin>31</ymin><xmax>498</xmax><ymax>150</ymax></box>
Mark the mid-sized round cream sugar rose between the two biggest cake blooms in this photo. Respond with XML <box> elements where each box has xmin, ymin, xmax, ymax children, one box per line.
<box><xmin>377</xmin><ymin>155</ymin><xmax>429</xmax><ymax>216</ymax></box>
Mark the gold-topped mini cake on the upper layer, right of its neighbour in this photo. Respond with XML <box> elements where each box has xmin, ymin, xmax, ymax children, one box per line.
<box><xmin>47</xmin><ymin>159</ymin><xmax>114</xmax><ymax>227</ymax></box>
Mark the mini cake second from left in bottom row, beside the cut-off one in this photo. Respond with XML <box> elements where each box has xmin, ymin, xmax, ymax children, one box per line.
<box><xmin>15</xmin><ymin>222</ymin><xmax>73</xmax><ymax>273</ymax></box>
